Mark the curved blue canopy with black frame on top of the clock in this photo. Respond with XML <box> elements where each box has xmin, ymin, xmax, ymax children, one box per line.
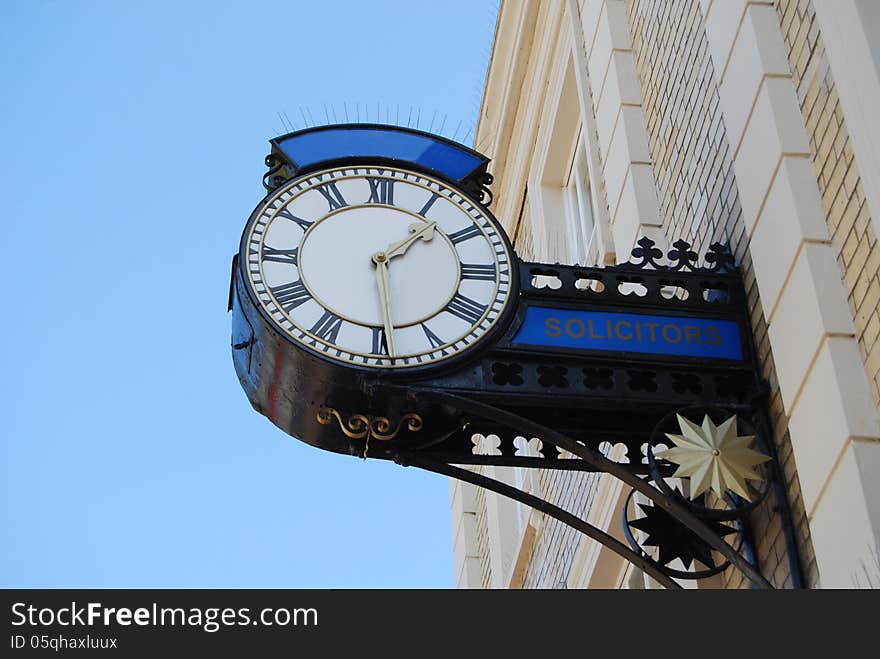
<box><xmin>267</xmin><ymin>124</ymin><xmax>489</xmax><ymax>191</ymax></box>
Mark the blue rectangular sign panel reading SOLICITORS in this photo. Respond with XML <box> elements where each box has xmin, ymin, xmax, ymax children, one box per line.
<box><xmin>513</xmin><ymin>306</ymin><xmax>743</xmax><ymax>360</ymax></box>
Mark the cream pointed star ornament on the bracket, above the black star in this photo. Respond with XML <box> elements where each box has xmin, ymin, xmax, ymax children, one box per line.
<box><xmin>655</xmin><ymin>414</ymin><xmax>770</xmax><ymax>500</ymax></box>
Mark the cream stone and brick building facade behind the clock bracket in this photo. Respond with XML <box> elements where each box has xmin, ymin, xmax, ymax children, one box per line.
<box><xmin>450</xmin><ymin>0</ymin><xmax>880</xmax><ymax>588</ymax></box>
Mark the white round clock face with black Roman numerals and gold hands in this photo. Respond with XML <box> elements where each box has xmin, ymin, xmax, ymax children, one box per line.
<box><xmin>240</xmin><ymin>166</ymin><xmax>512</xmax><ymax>369</ymax></box>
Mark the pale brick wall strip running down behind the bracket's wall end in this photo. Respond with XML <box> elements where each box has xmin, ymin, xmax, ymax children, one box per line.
<box><xmin>627</xmin><ymin>0</ymin><xmax>818</xmax><ymax>588</ymax></box>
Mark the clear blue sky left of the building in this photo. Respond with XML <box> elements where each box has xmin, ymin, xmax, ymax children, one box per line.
<box><xmin>0</xmin><ymin>0</ymin><xmax>497</xmax><ymax>588</ymax></box>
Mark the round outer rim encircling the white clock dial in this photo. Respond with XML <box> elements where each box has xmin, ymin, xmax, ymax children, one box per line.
<box><xmin>236</xmin><ymin>158</ymin><xmax>520</xmax><ymax>378</ymax></box>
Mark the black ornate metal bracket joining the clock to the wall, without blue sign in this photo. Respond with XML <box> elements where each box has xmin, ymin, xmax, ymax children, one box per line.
<box><xmin>374</xmin><ymin>238</ymin><xmax>802</xmax><ymax>588</ymax></box>
